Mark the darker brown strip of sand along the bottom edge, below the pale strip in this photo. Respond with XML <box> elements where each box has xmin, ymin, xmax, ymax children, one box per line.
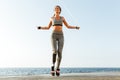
<box><xmin>0</xmin><ymin>76</ymin><xmax>120</xmax><ymax>80</ymax></box>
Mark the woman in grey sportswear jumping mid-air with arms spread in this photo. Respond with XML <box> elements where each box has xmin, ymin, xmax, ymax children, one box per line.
<box><xmin>38</xmin><ymin>5</ymin><xmax>80</xmax><ymax>76</ymax></box>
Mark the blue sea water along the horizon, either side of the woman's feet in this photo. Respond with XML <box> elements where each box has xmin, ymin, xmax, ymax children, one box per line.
<box><xmin>0</xmin><ymin>68</ymin><xmax>120</xmax><ymax>76</ymax></box>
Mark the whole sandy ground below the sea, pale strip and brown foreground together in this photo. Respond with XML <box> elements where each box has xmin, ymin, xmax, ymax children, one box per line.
<box><xmin>0</xmin><ymin>73</ymin><xmax>120</xmax><ymax>80</ymax></box>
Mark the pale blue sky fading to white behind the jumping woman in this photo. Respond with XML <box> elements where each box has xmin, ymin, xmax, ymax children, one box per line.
<box><xmin>0</xmin><ymin>0</ymin><xmax>120</xmax><ymax>68</ymax></box>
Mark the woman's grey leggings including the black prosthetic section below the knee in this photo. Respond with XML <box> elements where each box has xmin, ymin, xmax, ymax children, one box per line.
<box><xmin>51</xmin><ymin>31</ymin><xmax>64</xmax><ymax>69</ymax></box>
